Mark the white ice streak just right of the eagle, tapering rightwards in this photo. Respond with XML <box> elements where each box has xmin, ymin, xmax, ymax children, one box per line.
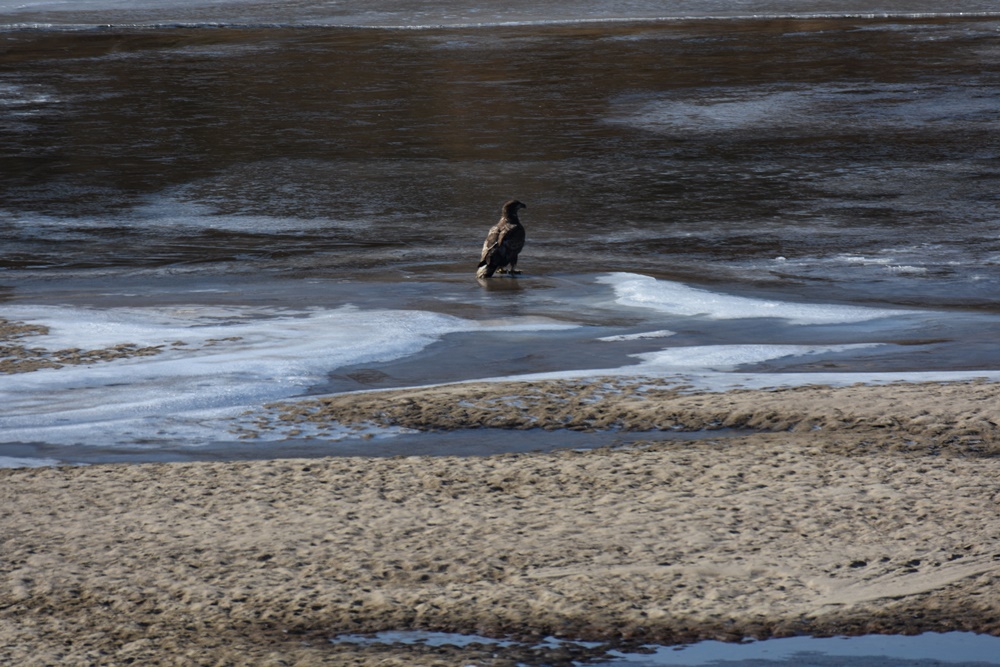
<box><xmin>598</xmin><ymin>273</ymin><xmax>916</xmax><ymax>324</ymax></box>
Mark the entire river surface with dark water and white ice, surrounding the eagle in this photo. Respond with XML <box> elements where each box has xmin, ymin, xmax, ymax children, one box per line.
<box><xmin>0</xmin><ymin>0</ymin><xmax>1000</xmax><ymax>463</ymax></box>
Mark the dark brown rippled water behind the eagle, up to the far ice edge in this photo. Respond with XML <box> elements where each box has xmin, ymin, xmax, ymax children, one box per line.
<box><xmin>0</xmin><ymin>18</ymin><xmax>1000</xmax><ymax>309</ymax></box>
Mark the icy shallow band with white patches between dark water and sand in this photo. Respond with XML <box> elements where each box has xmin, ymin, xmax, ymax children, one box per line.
<box><xmin>0</xmin><ymin>273</ymin><xmax>1000</xmax><ymax>462</ymax></box>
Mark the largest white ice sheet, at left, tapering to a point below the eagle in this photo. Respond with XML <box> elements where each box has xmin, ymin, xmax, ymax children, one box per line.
<box><xmin>0</xmin><ymin>306</ymin><xmax>568</xmax><ymax>446</ymax></box>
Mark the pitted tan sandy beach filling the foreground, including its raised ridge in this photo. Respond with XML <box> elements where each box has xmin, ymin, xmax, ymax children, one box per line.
<box><xmin>0</xmin><ymin>381</ymin><xmax>1000</xmax><ymax>665</ymax></box>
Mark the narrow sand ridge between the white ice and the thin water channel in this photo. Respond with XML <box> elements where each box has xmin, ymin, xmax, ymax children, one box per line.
<box><xmin>254</xmin><ymin>378</ymin><xmax>1000</xmax><ymax>454</ymax></box>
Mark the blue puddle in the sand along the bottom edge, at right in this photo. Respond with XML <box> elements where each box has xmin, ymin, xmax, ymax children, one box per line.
<box><xmin>330</xmin><ymin>631</ymin><xmax>1000</xmax><ymax>667</ymax></box>
